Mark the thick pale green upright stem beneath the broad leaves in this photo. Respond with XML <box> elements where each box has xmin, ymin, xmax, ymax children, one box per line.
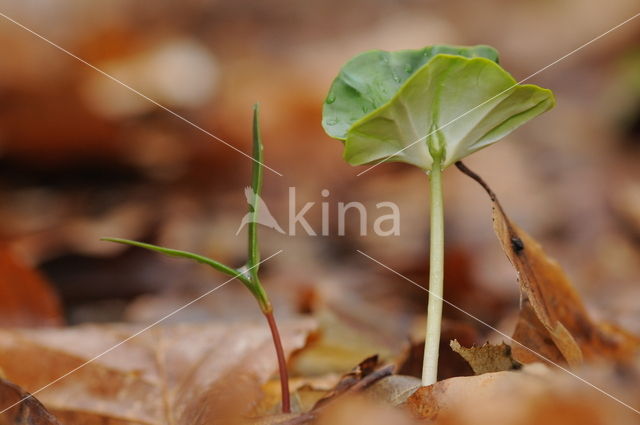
<box><xmin>422</xmin><ymin>158</ymin><xmax>444</xmax><ymax>386</ymax></box>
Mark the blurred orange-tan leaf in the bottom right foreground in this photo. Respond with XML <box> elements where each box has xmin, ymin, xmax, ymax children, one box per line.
<box><xmin>404</xmin><ymin>363</ymin><xmax>640</xmax><ymax>425</ymax></box>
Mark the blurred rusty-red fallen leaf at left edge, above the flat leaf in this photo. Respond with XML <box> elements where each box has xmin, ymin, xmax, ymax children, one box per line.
<box><xmin>0</xmin><ymin>246</ymin><xmax>62</xmax><ymax>326</ymax></box>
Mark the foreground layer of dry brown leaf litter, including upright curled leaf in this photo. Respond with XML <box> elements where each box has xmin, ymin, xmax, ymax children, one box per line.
<box><xmin>0</xmin><ymin>161</ymin><xmax>640</xmax><ymax>425</ymax></box>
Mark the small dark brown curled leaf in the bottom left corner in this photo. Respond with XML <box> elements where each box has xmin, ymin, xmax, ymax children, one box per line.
<box><xmin>0</xmin><ymin>379</ymin><xmax>60</xmax><ymax>425</ymax></box>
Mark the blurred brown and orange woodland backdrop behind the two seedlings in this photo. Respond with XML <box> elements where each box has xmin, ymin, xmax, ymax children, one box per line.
<box><xmin>0</xmin><ymin>0</ymin><xmax>640</xmax><ymax>372</ymax></box>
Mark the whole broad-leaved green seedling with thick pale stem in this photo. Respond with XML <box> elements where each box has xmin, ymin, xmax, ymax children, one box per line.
<box><xmin>322</xmin><ymin>45</ymin><xmax>555</xmax><ymax>386</ymax></box>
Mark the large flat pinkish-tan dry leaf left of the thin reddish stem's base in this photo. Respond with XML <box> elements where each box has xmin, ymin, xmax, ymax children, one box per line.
<box><xmin>0</xmin><ymin>320</ymin><xmax>314</xmax><ymax>425</ymax></box>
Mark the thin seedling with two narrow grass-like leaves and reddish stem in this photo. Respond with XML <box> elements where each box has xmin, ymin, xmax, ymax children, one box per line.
<box><xmin>102</xmin><ymin>105</ymin><xmax>291</xmax><ymax>413</ymax></box>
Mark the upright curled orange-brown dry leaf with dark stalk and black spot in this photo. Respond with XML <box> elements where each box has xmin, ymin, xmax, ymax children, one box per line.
<box><xmin>456</xmin><ymin>162</ymin><xmax>640</xmax><ymax>366</ymax></box>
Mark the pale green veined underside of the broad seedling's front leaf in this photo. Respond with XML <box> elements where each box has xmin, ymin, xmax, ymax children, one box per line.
<box><xmin>325</xmin><ymin>48</ymin><xmax>555</xmax><ymax>171</ymax></box>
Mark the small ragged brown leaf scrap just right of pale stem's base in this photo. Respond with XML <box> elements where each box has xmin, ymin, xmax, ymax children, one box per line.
<box><xmin>450</xmin><ymin>339</ymin><xmax>522</xmax><ymax>375</ymax></box>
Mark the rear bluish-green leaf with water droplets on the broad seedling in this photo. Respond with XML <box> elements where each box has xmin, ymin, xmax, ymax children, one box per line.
<box><xmin>322</xmin><ymin>45</ymin><xmax>498</xmax><ymax>140</ymax></box>
